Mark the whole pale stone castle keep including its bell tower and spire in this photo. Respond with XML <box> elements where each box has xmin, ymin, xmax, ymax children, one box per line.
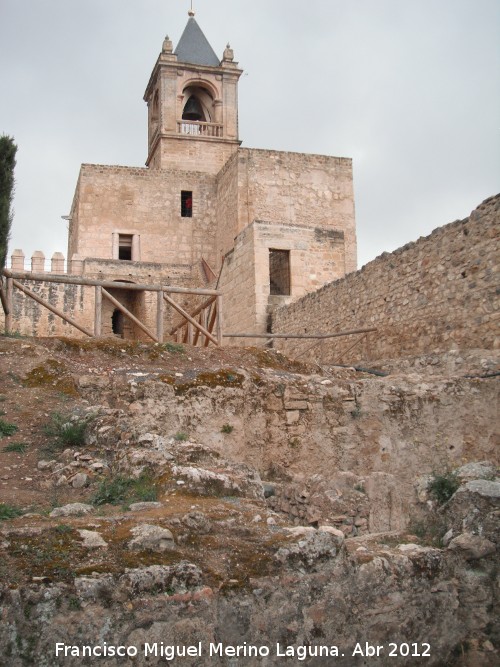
<box><xmin>59</xmin><ymin>12</ymin><xmax>356</xmax><ymax>336</ymax></box>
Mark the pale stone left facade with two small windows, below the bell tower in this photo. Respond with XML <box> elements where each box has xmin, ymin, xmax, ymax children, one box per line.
<box><xmin>68</xmin><ymin>165</ymin><xmax>216</xmax><ymax>272</ymax></box>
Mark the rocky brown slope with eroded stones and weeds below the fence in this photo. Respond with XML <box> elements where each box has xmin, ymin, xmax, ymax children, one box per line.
<box><xmin>0</xmin><ymin>337</ymin><xmax>500</xmax><ymax>667</ymax></box>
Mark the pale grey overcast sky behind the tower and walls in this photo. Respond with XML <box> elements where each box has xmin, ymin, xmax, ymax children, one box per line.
<box><xmin>0</xmin><ymin>0</ymin><xmax>500</xmax><ymax>266</ymax></box>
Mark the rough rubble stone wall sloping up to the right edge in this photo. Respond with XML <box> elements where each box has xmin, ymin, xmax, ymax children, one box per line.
<box><xmin>273</xmin><ymin>196</ymin><xmax>500</xmax><ymax>362</ymax></box>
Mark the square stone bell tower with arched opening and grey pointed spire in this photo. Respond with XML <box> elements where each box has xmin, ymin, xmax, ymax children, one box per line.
<box><xmin>144</xmin><ymin>10</ymin><xmax>242</xmax><ymax>173</ymax></box>
